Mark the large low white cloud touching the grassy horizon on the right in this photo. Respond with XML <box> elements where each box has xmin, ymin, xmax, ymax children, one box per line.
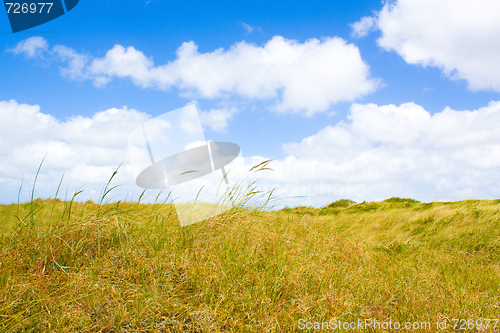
<box><xmin>250</xmin><ymin>101</ymin><xmax>500</xmax><ymax>205</ymax></box>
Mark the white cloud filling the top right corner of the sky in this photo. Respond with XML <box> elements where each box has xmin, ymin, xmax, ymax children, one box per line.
<box><xmin>352</xmin><ymin>0</ymin><xmax>500</xmax><ymax>91</ymax></box>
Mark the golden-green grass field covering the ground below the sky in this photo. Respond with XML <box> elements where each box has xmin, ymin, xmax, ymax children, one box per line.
<box><xmin>0</xmin><ymin>189</ymin><xmax>500</xmax><ymax>332</ymax></box>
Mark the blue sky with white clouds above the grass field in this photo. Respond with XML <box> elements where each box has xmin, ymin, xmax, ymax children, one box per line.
<box><xmin>0</xmin><ymin>0</ymin><xmax>500</xmax><ymax>207</ymax></box>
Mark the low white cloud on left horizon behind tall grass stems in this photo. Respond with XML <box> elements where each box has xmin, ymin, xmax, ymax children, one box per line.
<box><xmin>0</xmin><ymin>100</ymin><xmax>150</xmax><ymax>203</ymax></box>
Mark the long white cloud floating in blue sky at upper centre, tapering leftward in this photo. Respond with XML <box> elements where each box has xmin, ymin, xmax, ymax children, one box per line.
<box><xmin>9</xmin><ymin>36</ymin><xmax>381</xmax><ymax>116</ymax></box>
